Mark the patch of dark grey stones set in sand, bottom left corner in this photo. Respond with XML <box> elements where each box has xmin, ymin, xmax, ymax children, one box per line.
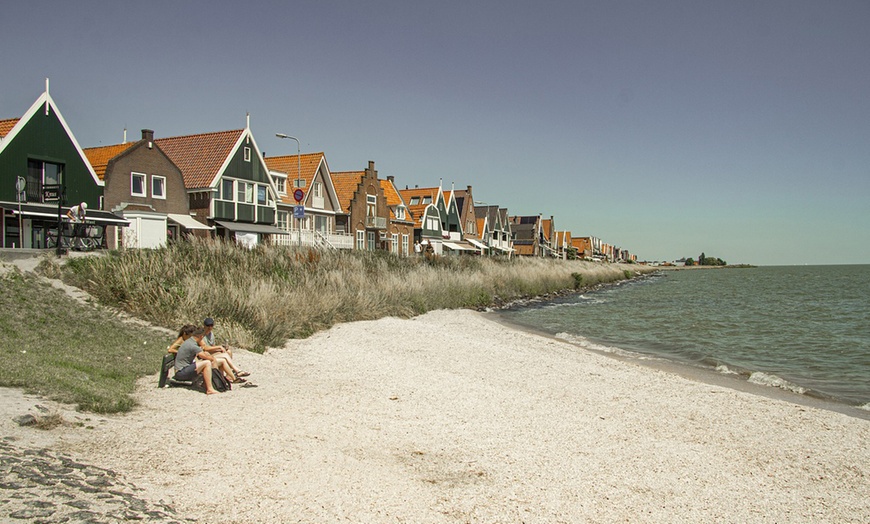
<box><xmin>0</xmin><ymin>437</ymin><xmax>193</xmax><ymax>524</ymax></box>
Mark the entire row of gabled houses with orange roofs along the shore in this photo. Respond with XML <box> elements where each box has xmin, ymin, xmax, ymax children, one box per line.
<box><xmin>0</xmin><ymin>83</ymin><xmax>633</xmax><ymax>260</ymax></box>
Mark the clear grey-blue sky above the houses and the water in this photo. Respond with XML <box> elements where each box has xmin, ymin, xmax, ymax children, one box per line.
<box><xmin>0</xmin><ymin>0</ymin><xmax>870</xmax><ymax>265</ymax></box>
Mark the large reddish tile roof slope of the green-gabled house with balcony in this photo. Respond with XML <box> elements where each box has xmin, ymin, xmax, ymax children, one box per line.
<box><xmin>154</xmin><ymin>129</ymin><xmax>245</xmax><ymax>189</ymax></box>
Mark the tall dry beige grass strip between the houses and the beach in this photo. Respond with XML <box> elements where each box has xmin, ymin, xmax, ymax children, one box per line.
<box><xmin>47</xmin><ymin>240</ymin><xmax>641</xmax><ymax>351</ymax></box>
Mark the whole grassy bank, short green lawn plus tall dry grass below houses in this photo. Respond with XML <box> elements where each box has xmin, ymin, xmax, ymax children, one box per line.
<box><xmin>0</xmin><ymin>241</ymin><xmax>648</xmax><ymax>412</ymax></box>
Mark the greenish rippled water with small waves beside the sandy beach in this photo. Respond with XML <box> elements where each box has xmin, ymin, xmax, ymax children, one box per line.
<box><xmin>499</xmin><ymin>265</ymin><xmax>870</xmax><ymax>410</ymax></box>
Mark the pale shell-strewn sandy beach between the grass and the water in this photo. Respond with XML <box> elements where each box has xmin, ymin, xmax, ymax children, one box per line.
<box><xmin>0</xmin><ymin>310</ymin><xmax>870</xmax><ymax>523</ymax></box>
